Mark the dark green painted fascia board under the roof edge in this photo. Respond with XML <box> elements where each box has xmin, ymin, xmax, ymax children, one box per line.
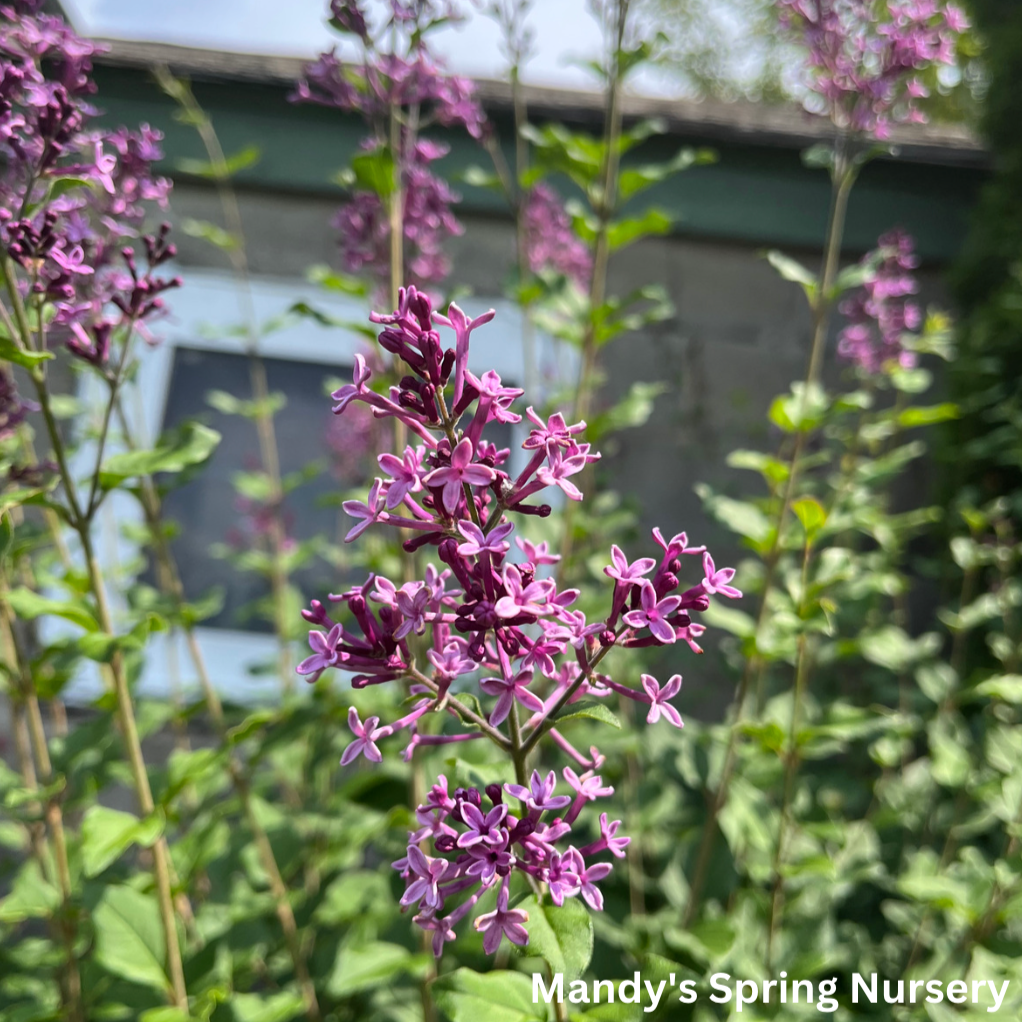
<box><xmin>96</xmin><ymin>66</ymin><xmax>986</xmax><ymax>263</ymax></box>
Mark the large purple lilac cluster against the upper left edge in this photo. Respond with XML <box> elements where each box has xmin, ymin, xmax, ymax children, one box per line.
<box><xmin>0</xmin><ymin>3</ymin><xmax>178</xmax><ymax>366</ymax></box>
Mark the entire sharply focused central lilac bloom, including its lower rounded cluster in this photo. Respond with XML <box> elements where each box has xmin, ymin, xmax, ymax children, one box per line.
<box><xmin>297</xmin><ymin>286</ymin><xmax>741</xmax><ymax>954</ymax></box>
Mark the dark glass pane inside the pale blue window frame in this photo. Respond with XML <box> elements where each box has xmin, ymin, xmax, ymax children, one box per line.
<box><xmin>157</xmin><ymin>346</ymin><xmax>511</xmax><ymax>632</ymax></box>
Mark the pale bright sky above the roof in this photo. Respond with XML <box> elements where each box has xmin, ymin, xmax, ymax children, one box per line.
<box><xmin>63</xmin><ymin>0</ymin><xmax>670</xmax><ymax>95</ymax></box>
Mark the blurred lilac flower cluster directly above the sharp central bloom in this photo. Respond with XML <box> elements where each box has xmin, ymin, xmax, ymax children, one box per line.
<box><xmin>293</xmin><ymin>0</ymin><xmax>486</xmax><ymax>287</ymax></box>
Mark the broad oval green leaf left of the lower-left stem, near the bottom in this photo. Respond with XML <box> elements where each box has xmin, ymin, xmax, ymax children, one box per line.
<box><xmin>92</xmin><ymin>884</ymin><xmax>170</xmax><ymax>991</ymax></box>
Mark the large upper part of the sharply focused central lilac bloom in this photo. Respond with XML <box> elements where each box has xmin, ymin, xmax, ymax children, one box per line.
<box><xmin>299</xmin><ymin>287</ymin><xmax>740</xmax><ymax>756</ymax></box>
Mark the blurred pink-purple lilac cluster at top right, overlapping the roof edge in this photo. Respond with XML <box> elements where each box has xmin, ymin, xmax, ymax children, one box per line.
<box><xmin>779</xmin><ymin>0</ymin><xmax>969</xmax><ymax>139</ymax></box>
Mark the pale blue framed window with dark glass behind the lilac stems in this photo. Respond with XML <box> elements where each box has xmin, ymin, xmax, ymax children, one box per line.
<box><xmin>69</xmin><ymin>269</ymin><xmax>573</xmax><ymax>701</ymax></box>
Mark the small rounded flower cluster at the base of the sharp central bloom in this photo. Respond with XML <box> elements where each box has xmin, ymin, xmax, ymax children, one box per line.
<box><xmin>393</xmin><ymin>768</ymin><xmax>631</xmax><ymax>958</ymax></box>
